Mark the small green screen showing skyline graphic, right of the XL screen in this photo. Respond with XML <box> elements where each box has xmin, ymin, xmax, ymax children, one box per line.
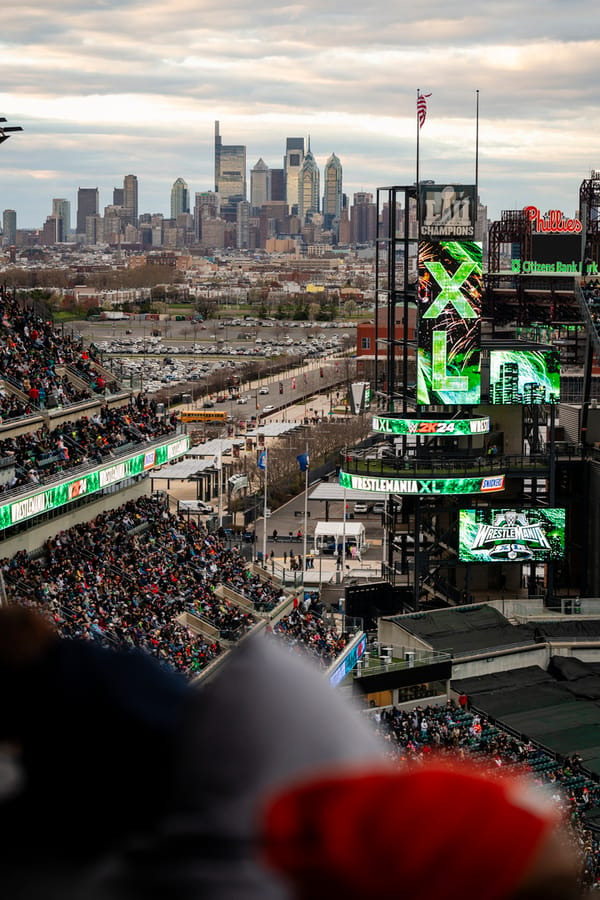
<box><xmin>490</xmin><ymin>350</ymin><xmax>560</xmax><ymax>404</ymax></box>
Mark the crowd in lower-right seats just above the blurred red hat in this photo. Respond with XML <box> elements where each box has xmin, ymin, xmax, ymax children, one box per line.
<box><xmin>370</xmin><ymin>702</ymin><xmax>600</xmax><ymax>890</ymax></box>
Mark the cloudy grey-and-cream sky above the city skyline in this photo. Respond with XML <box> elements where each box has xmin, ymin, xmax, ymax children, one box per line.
<box><xmin>0</xmin><ymin>0</ymin><xmax>600</xmax><ymax>228</ymax></box>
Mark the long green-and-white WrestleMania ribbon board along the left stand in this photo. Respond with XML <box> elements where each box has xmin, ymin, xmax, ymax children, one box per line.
<box><xmin>0</xmin><ymin>435</ymin><xmax>190</xmax><ymax>530</ymax></box>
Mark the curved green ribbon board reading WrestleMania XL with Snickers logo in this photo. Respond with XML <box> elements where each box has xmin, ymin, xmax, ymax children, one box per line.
<box><xmin>339</xmin><ymin>472</ymin><xmax>505</xmax><ymax>495</ymax></box>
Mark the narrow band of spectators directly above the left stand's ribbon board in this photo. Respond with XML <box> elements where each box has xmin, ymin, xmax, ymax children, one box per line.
<box><xmin>0</xmin><ymin>394</ymin><xmax>177</xmax><ymax>491</ymax></box>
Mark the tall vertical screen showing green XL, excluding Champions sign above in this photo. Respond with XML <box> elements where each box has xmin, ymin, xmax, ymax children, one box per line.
<box><xmin>417</xmin><ymin>241</ymin><xmax>482</xmax><ymax>405</ymax></box>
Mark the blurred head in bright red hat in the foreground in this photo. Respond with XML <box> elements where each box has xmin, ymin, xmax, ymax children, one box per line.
<box><xmin>262</xmin><ymin>761</ymin><xmax>583</xmax><ymax>900</ymax></box>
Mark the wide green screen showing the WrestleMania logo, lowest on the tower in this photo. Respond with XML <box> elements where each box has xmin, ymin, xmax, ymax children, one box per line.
<box><xmin>458</xmin><ymin>508</ymin><xmax>565</xmax><ymax>563</ymax></box>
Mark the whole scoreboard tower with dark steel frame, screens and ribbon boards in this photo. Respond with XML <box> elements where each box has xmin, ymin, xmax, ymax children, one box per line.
<box><xmin>340</xmin><ymin>183</ymin><xmax>572</xmax><ymax>609</ymax></box>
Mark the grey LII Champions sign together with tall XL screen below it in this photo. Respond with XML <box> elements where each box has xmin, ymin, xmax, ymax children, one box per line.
<box><xmin>417</xmin><ymin>184</ymin><xmax>482</xmax><ymax>405</ymax></box>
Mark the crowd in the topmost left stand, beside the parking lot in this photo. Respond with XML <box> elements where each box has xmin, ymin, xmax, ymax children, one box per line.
<box><xmin>0</xmin><ymin>285</ymin><xmax>117</xmax><ymax>421</ymax></box>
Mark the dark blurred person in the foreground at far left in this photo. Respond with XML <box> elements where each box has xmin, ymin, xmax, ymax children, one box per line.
<box><xmin>0</xmin><ymin>606</ymin><xmax>191</xmax><ymax>900</ymax></box>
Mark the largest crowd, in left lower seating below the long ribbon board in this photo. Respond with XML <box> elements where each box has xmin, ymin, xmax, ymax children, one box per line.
<box><xmin>1</xmin><ymin>497</ymin><xmax>281</xmax><ymax>676</ymax></box>
